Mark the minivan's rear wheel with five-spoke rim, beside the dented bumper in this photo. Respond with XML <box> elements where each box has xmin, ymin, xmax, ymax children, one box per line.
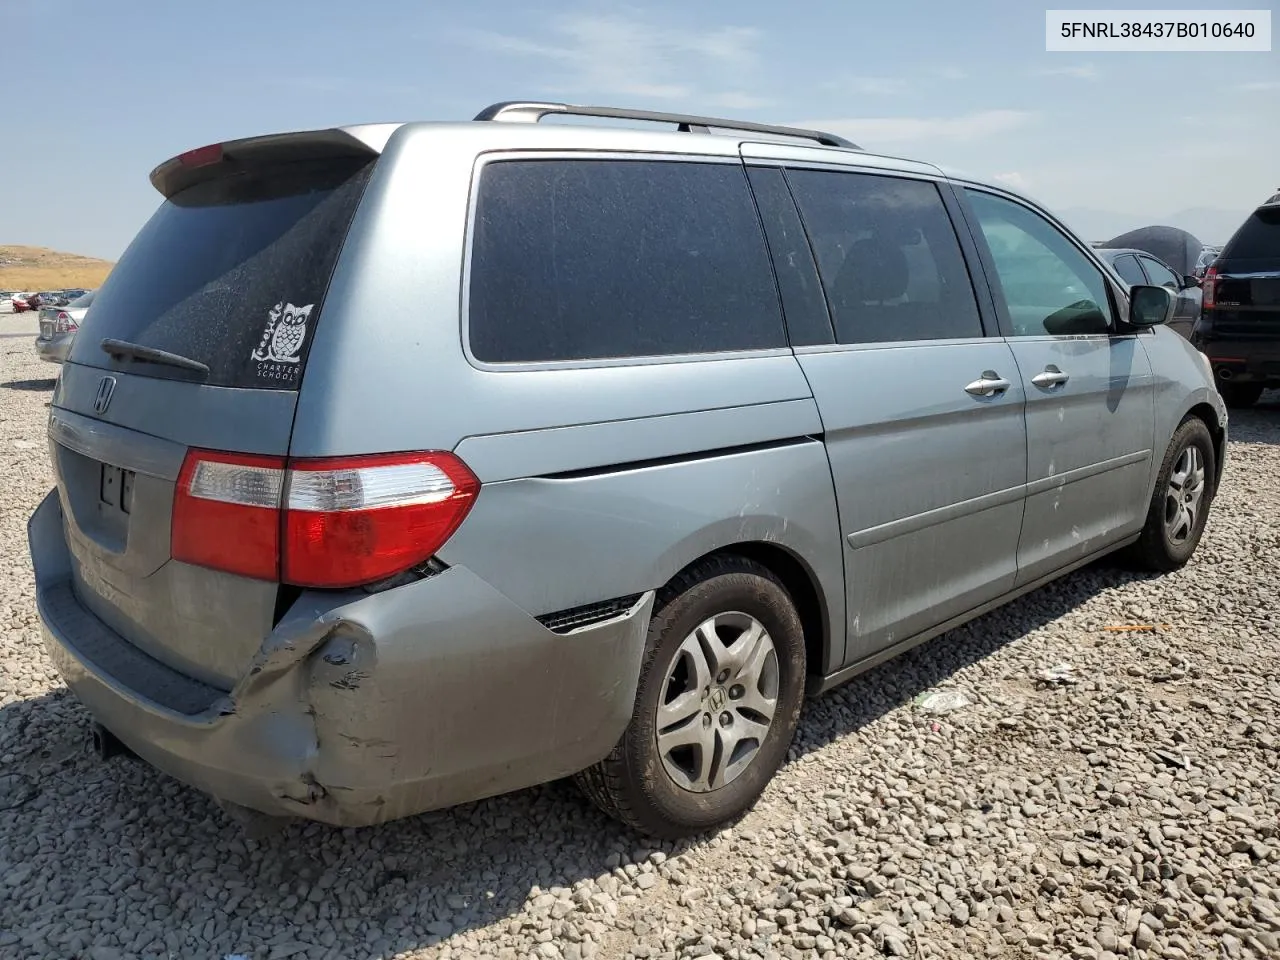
<box><xmin>576</xmin><ymin>556</ymin><xmax>805</xmax><ymax>840</ymax></box>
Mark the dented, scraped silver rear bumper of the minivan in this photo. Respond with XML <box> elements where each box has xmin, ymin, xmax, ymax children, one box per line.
<box><xmin>28</xmin><ymin>492</ymin><xmax>653</xmax><ymax>826</ymax></box>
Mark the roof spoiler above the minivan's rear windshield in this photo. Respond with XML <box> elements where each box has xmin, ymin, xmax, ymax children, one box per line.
<box><xmin>151</xmin><ymin>123</ymin><xmax>399</xmax><ymax>200</ymax></box>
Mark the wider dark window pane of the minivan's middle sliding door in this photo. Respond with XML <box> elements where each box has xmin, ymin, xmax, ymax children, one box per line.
<box><xmin>787</xmin><ymin>170</ymin><xmax>982</xmax><ymax>343</ymax></box>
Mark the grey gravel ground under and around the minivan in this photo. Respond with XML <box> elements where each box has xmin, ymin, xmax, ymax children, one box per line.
<box><xmin>0</xmin><ymin>317</ymin><xmax>1280</xmax><ymax>960</ymax></box>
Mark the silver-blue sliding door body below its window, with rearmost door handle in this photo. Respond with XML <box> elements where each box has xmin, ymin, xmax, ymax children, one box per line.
<box><xmin>800</xmin><ymin>338</ymin><xmax>1027</xmax><ymax>662</ymax></box>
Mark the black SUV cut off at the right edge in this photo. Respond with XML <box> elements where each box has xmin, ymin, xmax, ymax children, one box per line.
<box><xmin>1192</xmin><ymin>195</ymin><xmax>1280</xmax><ymax>407</ymax></box>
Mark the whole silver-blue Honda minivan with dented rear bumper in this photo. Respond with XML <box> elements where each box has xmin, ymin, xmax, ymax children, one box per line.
<box><xmin>28</xmin><ymin>102</ymin><xmax>1226</xmax><ymax>837</ymax></box>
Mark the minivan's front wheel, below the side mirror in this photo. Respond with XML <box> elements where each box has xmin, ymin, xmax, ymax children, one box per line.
<box><xmin>1126</xmin><ymin>416</ymin><xmax>1217</xmax><ymax>572</ymax></box>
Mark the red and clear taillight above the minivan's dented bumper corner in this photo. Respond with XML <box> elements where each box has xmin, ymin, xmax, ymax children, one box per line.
<box><xmin>172</xmin><ymin>451</ymin><xmax>480</xmax><ymax>588</ymax></box>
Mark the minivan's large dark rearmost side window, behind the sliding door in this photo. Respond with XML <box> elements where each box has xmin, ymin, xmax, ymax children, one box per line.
<box><xmin>470</xmin><ymin>160</ymin><xmax>786</xmax><ymax>362</ymax></box>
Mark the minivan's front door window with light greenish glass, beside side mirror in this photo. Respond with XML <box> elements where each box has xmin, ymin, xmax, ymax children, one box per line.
<box><xmin>965</xmin><ymin>191</ymin><xmax>1111</xmax><ymax>337</ymax></box>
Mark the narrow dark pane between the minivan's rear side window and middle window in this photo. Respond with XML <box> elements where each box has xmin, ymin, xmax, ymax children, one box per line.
<box><xmin>748</xmin><ymin>166</ymin><xmax>833</xmax><ymax>347</ymax></box>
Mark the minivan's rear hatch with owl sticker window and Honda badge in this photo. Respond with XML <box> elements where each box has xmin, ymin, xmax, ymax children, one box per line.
<box><xmin>50</xmin><ymin>142</ymin><xmax>376</xmax><ymax>690</ymax></box>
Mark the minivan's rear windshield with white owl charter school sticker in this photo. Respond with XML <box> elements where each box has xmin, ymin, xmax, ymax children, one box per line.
<box><xmin>72</xmin><ymin>160</ymin><xmax>372</xmax><ymax>389</ymax></box>
